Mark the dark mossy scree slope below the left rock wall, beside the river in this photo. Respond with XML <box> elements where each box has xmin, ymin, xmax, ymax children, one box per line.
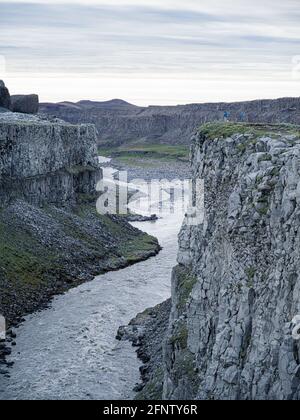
<box><xmin>0</xmin><ymin>202</ymin><xmax>160</xmax><ymax>321</ymax></box>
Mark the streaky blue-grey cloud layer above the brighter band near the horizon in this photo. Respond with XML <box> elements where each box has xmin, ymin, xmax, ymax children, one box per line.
<box><xmin>0</xmin><ymin>0</ymin><xmax>300</xmax><ymax>102</ymax></box>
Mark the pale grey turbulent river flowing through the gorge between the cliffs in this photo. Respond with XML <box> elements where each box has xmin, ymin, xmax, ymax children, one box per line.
<box><xmin>0</xmin><ymin>160</ymin><xmax>183</xmax><ymax>400</ymax></box>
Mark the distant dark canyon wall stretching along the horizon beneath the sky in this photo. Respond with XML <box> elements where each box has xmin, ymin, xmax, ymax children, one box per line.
<box><xmin>40</xmin><ymin>98</ymin><xmax>300</xmax><ymax>146</ymax></box>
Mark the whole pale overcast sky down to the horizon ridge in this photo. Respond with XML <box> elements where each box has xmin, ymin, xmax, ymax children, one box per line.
<box><xmin>0</xmin><ymin>0</ymin><xmax>300</xmax><ymax>105</ymax></box>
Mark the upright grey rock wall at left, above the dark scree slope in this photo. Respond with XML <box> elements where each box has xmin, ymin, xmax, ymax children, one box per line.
<box><xmin>0</xmin><ymin>113</ymin><xmax>100</xmax><ymax>205</ymax></box>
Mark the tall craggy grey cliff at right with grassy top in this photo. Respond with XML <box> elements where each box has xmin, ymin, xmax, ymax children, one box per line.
<box><xmin>164</xmin><ymin>125</ymin><xmax>300</xmax><ymax>400</ymax></box>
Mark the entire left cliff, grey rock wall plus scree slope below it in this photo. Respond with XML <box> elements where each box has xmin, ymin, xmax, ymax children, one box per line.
<box><xmin>0</xmin><ymin>113</ymin><xmax>159</xmax><ymax>330</ymax></box>
